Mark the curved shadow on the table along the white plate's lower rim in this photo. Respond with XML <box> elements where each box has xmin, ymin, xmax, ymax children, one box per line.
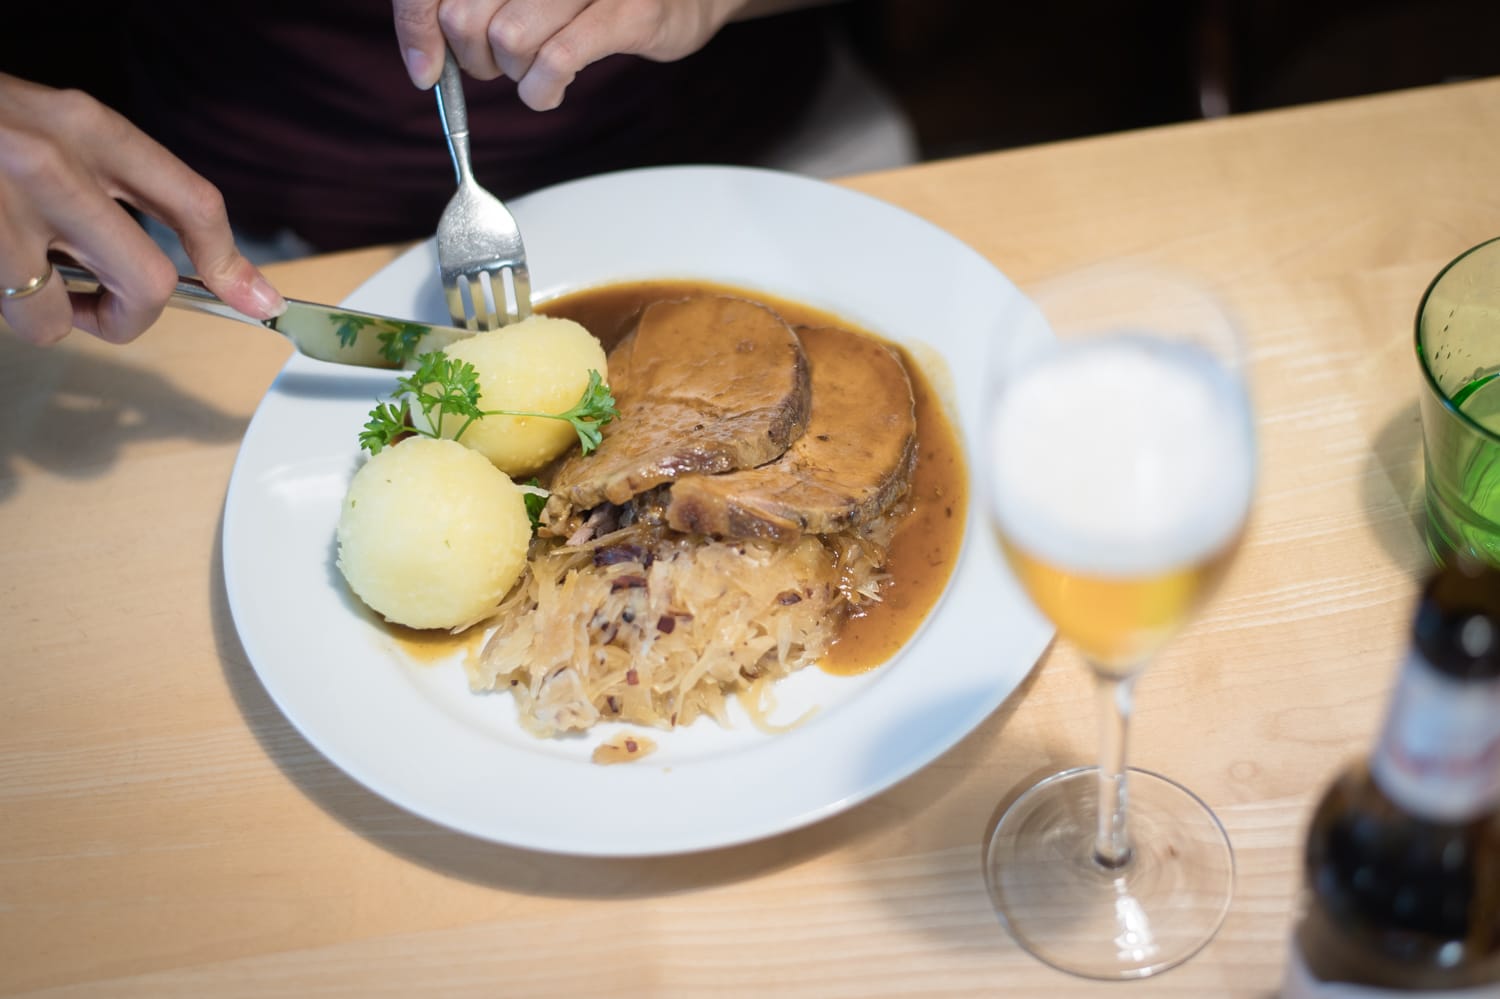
<box><xmin>210</xmin><ymin>518</ymin><xmax>1031</xmax><ymax>899</ymax></box>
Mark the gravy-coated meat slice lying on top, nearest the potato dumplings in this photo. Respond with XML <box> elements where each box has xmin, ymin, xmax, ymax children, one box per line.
<box><xmin>546</xmin><ymin>296</ymin><xmax>812</xmax><ymax>513</ymax></box>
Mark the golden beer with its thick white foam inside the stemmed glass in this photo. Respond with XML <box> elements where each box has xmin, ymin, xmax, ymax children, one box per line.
<box><xmin>990</xmin><ymin>336</ymin><xmax>1254</xmax><ymax>672</ymax></box>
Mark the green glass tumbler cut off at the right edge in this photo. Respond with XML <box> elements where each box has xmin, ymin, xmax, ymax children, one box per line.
<box><xmin>1416</xmin><ymin>231</ymin><xmax>1500</xmax><ymax>566</ymax></box>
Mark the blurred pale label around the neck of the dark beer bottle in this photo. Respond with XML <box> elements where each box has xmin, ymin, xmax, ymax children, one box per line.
<box><xmin>1370</xmin><ymin>654</ymin><xmax>1500</xmax><ymax>822</ymax></box>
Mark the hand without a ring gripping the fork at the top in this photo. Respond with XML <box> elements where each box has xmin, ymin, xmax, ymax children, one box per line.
<box><xmin>392</xmin><ymin>0</ymin><xmax>756</xmax><ymax>111</ymax></box>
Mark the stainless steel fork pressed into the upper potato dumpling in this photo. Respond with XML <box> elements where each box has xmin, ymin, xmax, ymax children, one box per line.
<box><xmin>437</xmin><ymin>51</ymin><xmax>531</xmax><ymax>330</ymax></box>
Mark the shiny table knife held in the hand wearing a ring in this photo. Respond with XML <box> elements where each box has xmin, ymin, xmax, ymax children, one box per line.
<box><xmin>56</xmin><ymin>264</ymin><xmax>474</xmax><ymax>368</ymax></box>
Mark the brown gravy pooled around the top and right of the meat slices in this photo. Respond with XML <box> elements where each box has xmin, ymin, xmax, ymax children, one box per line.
<box><xmin>537</xmin><ymin>281</ymin><xmax>969</xmax><ymax>675</ymax></box>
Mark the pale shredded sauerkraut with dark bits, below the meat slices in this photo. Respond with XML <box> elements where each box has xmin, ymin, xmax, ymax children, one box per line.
<box><xmin>468</xmin><ymin>500</ymin><xmax>909</xmax><ymax>737</ymax></box>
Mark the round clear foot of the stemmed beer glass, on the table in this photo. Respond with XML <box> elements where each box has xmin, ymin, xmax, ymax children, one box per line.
<box><xmin>984</xmin><ymin>767</ymin><xmax>1235</xmax><ymax>980</ymax></box>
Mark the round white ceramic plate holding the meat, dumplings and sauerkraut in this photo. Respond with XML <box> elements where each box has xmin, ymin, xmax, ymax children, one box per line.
<box><xmin>224</xmin><ymin>167</ymin><xmax>1050</xmax><ymax>857</ymax></box>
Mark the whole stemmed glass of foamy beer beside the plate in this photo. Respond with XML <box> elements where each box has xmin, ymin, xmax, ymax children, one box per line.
<box><xmin>984</xmin><ymin>269</ymin><xmax>1256</xmax><ymax>978</ymax></box>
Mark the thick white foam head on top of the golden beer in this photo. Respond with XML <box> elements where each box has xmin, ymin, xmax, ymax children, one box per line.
<box><xmin>989</xmin><ymin>335</ymin><xmax>1256</xmax><ymax>576</ymax></box>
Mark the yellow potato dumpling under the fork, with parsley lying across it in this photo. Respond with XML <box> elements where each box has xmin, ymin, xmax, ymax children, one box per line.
<box><xmin>443</xmin><ymin>315</ymin><xmax>609</xmax><ymax>479</ymax></box>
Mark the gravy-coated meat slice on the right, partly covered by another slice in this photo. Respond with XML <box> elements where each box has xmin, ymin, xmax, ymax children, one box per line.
<box><xmin>666</xmin><ymin>327</ymin><xmax>917</xmax><ymax>539</ymax></box>
